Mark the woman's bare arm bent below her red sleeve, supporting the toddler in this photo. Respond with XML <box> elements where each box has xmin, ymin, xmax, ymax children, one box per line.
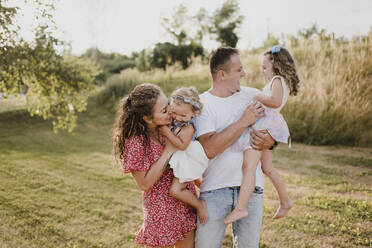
<box><xmin>132</xmin><ymin>142</ymin><xmax>176</xmax><ymax>191</ymax></box>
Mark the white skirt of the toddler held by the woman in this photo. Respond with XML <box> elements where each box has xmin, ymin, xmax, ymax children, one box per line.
<box><xmin>169</xmin><ymin>119</ymin><xmax>208</xmax><ymax>183</ymax></box>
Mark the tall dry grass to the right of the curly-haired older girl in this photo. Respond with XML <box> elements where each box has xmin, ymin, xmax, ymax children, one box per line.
<box><xmin>283</xmin><ymin>32</ymin><xmax>372</xmax><ymax>146</ymax></box>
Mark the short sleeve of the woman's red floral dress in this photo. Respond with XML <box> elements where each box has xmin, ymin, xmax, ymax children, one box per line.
<box><xmin>123</xmin><ymin>136</ymin><xmax>151</xmax><ymax>173</ymax></box>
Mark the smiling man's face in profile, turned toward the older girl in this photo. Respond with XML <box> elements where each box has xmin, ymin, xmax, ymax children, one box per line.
<box><xmin>224</xmin><ymin>54</ymin><xmax>245</xmax><ymax>93</ymax></box>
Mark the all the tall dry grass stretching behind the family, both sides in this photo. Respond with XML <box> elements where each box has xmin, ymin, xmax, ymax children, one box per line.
<box><xmin>96</xmin><ymin>31</ymin><xmax>372</xmax><ymax>146</ymax></box>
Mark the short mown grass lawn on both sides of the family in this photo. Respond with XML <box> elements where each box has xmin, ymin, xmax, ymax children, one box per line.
<box><xmin>0</xmin><ymin>101</ymin><xmax>372</xmax><ymax>248</ymax></box>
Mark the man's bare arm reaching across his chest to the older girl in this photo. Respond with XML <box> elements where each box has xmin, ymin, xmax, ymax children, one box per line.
<box><xmin>198</xmin><ymin>102</ymin><xmax>264</xmax><ymax>159</ymax></box>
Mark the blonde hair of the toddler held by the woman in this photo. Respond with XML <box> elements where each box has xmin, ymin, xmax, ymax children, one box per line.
<box><xmin>171</xmin><ymin>86</ymin><xmax>203</xmax><ymax>115</ymax></box>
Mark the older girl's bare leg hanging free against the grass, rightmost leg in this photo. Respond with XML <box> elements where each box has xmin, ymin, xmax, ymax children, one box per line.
<box><xmin>261</xmin><ymin>150</ymin><xmax>293</xmax><ymax>219</ymax></box>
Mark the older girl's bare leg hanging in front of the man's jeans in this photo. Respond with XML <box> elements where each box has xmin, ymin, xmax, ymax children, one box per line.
<box><xmin>223</xmin><ymin>149</ymin><xmax>261</xmax><ymax>224</ymax></box>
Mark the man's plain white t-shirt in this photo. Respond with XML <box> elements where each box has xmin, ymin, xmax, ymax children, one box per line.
<box><xmin>194</xmin><ymin>87</ymin><xmax>264</xmax><ymax>192</ymax></box>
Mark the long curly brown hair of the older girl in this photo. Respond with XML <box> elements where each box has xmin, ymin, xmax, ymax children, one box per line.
<box><xmin>264</xmin><ymin>47</ymin><xmax>300</xmax><ymax>95</ymax></box>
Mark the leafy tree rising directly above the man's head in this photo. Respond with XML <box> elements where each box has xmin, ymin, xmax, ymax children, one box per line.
<box><xmin>209</xmin><ymin>0</ymin><xmax>244</xmax><ymax>47</ymax></box>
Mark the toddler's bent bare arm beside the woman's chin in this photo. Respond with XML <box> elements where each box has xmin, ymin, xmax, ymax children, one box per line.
<box><xmin>160</xmin><ymin>124</ymin><xmax>194</xmax><ymax>151</ymax></box>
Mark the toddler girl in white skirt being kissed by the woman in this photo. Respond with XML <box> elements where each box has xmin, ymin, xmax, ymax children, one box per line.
<box><xmin>160</xmin><ymin>87</ymin><xmax>208</xmax><ymax>224</ymax></box>
